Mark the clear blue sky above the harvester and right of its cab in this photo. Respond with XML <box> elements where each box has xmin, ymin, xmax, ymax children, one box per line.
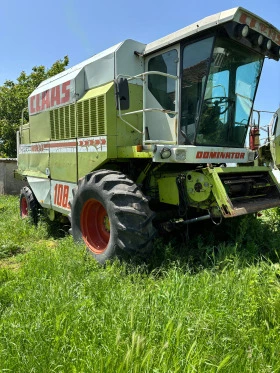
<box><xmin>0</xmin><ymin>0</ymin><xmax>280</xmax><ymax>133</ymax></box>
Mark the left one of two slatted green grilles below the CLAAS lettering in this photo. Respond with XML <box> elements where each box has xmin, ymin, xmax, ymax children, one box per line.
<box><xmin>50</xmin><ymin>104</ymin><xmax>76</xmax><ymax>140</ymax></box>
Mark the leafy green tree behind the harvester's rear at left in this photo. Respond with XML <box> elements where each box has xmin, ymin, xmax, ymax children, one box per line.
<box><xmin>0</xmin><ymin>56</ymin><xmax>69</xmax><ymax>158</ymax></box>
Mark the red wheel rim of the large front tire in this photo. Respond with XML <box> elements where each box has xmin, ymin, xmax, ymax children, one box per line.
<box><xmin>80</xmin><ymin>199</ymin><xmax>110</xmax><ymax>254</ymax></box>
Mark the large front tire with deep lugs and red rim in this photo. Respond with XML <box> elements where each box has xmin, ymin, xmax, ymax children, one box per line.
<box><xmin>70</xmin><ymin>170</ymin><xmax>155</xmax><ymax>264</ymax></box>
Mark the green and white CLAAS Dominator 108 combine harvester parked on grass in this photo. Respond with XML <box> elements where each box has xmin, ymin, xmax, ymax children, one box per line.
<box><xmin>17</xmin><ymin>8</ymin><xmax>280</xmax><ymax>263</ymax></box>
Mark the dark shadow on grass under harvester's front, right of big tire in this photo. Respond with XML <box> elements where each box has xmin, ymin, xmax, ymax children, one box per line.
<box><xmin>142</xmin><ymin>209</ymin><xmax>280</xmax><ymax>272</ymax></box>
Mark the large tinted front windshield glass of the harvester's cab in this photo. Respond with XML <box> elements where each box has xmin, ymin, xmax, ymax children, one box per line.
<box><xmin>180</xmin><ymin>37</ymin><xmax>263</xmax><ymax>147</ymax></box>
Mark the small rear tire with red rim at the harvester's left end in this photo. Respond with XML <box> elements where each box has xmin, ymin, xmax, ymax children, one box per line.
<box><xmin>19</xmin><ymin>186</ymin><xmax>39</xmax><ymax>224</ymax></box>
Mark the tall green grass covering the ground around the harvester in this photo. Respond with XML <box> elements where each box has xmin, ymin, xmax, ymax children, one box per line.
<box><xmin>0</xmin><ymin>196</ymin><xmax>280</xmax><ymax>373</ymax></box>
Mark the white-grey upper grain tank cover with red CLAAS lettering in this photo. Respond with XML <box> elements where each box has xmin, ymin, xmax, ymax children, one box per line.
<box><xmin>28</xmin><ymin>40</ymin><xmax>146</xmax><ymax>115</ymax></box>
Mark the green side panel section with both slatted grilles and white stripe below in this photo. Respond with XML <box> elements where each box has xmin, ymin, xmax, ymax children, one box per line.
<box><xmin>47</xmin><ymin>83</ymin><xmax>116</xmax><ymax>183</ymax></box>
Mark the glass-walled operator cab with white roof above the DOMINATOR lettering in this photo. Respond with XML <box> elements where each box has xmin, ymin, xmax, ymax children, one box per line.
<box><xmin>144</xmin><ymin>10</ymin><xmax>280</xmax><ymax>148</ymax></box>
